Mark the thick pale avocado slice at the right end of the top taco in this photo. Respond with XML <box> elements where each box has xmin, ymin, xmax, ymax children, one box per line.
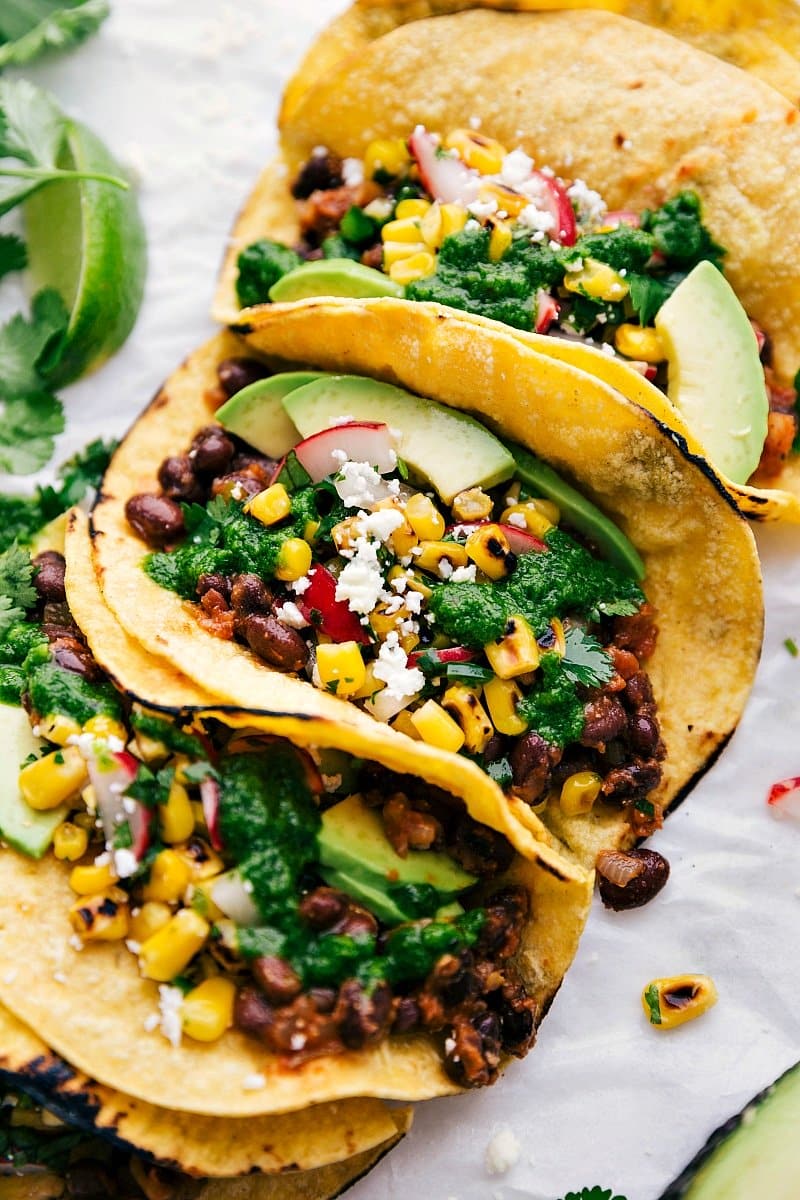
<box><xmin>656</xmin><ymin>262</ymin><xmax>769</xmax><ymax>484</ymax></box>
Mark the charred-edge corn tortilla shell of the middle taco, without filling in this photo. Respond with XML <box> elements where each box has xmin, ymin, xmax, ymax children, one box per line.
<box><xmin>90</xmin><ymin>312</ymin><xmax>762</xmax><ymax>865</ymax></box>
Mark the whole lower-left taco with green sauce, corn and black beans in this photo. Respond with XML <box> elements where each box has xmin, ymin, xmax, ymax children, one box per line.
<box><xmin>0</xmin><ymin>523</ymin><xmax>591</xmax><ymax>1123</ymax></box>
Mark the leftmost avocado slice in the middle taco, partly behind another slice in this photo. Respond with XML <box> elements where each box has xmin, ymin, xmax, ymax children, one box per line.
<box><xmin>217</xmin><ymin>371</ymin><xmax>321</xmax><ymax>458</ymax></box>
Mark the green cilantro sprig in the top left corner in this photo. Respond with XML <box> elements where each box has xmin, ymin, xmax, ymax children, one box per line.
<box><xmin>0</xmin><ymin>0</ymin><xmax>109</xmax><ymax>70</ymax></box>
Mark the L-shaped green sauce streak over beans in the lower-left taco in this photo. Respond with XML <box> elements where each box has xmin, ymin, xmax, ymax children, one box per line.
<box><xmin>219</xmin><ymin>745</ymin><xmax>485</xmax><ymax>988</ymax></box>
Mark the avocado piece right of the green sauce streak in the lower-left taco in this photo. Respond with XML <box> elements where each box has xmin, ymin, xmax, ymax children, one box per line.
<box><xmin>318</xmin><ymin>796</ymin><xmax>477</xmax><ymax>924</ymax></box>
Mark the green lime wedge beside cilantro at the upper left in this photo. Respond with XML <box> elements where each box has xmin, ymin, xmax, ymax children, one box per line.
<box><xmin>24</xmin><ymin>121</ymin><xmax>148</xmax><ymax>386</ymax></box>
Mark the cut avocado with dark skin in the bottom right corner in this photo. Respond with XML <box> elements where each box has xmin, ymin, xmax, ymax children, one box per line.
<box><xmin>661</xmin><ymin>1063</ymin><xmax>800</xmax><ymax>1200</ymax></box>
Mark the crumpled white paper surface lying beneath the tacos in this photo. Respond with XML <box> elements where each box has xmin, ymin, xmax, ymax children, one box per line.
<box><xmin>6</xmin><ymin>0</ymin><xmax>800</xmax><ymax>1200</ymax></box>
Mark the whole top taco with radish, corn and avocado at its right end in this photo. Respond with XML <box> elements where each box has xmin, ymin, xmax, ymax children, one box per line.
<box><xmin>217</xmin><ymin>11</ymin><xmax>800</xmax><ymax>522</ymax></box>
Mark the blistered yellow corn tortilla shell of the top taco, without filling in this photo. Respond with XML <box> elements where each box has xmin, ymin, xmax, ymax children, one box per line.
<box><xmin>215</xmin><ymin>7</ymin><xmax>800</xmax><ymax>522</ymax></box>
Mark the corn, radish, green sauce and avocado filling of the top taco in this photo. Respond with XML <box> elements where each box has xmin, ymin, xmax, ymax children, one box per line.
<box><xmin>236</xmin><ymin>127</ymin><xmax>798</xmax><ymax>484</ymax></box>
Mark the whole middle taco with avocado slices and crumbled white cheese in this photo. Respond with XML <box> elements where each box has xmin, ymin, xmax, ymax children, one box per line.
<box><xmin>91</xmin><ymin>309</ymin><xmax>762</xmax><ymax>866</ymax></box>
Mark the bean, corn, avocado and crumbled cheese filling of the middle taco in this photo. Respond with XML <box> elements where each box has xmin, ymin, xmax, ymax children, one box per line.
<box><xmin>126</xmin><ymin>369</ymin><xmax>664</xmax><ymax>853</ymax></box>
